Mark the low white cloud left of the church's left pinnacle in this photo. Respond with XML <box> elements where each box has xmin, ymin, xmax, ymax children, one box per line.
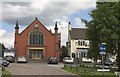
<box><xmin>0</xmin><ymin>29</ymin><xmax>14</xmax><ymax>48</ymax></box>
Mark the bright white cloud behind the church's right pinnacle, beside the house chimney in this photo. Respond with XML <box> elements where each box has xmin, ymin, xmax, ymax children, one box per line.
<box><xmin>42</xmin><ymin>16</ymin><xmax>68</xmax><ymax>45</ymax></box>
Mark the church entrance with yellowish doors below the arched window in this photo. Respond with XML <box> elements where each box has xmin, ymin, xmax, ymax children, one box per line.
<box><xmin>29</xmin><ymin>49</ymin><xmax>44</xmax><ymax>59</ymax></box>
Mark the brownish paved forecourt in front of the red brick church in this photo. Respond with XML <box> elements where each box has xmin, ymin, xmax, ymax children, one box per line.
<box><xmin>6</xmin><ymin>63</ymin><xmax>74</xmax><ymax>75</ymax></box>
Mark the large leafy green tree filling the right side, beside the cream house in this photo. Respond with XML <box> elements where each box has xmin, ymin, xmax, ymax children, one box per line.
<box><xmin>83</xmin><ymin>2</ymin><xmax>120</xmax><ymax>71</ymax></box>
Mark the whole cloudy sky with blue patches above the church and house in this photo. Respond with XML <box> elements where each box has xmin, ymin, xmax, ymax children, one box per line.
<box><xmin>0</xmin><ymin>0</ymin><xmax>96</xmax><ymax>48</ymax></box>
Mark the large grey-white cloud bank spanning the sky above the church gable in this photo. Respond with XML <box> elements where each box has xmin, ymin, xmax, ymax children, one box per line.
<box><xmin>2</xmin><ymin>0</ymin><xmax>95</xmax><ymax>26</ymax></box>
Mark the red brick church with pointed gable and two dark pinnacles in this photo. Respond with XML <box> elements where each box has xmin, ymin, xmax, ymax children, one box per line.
<box><xmin>14</xmin><ymin>18</ymin><xmax>61</xmax><ymax>59</ymax></box>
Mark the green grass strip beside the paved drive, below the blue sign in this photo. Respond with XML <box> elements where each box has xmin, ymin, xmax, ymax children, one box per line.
<box><xmin>62</xmin><ymin>66</ymin><xmax>116</xmax><ymax>77</ymax></box>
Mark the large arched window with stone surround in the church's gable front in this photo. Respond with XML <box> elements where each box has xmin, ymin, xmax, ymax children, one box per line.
<box><xmin>29</xmin><ymin>30</ymin><xmax>44</xmax><ymax>45</ymax></box>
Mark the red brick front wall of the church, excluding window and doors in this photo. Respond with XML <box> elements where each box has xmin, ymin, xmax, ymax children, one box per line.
<box><xmin>14</xmin><ymin>19</ymin><xmax>60</xmax><ymax>59</ymax></box>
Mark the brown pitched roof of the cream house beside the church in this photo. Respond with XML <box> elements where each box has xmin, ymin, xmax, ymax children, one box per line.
<box><xmin>69</xmin><ymin>28</ymin><xmax>87</xmax><ymax>39</ymax></box>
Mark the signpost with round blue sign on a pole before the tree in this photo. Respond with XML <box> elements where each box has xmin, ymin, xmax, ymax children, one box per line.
<box><xmin>99</xmin><ymin>43</ymin><xmax>106</xmax><ymax>76</ymax></box>
